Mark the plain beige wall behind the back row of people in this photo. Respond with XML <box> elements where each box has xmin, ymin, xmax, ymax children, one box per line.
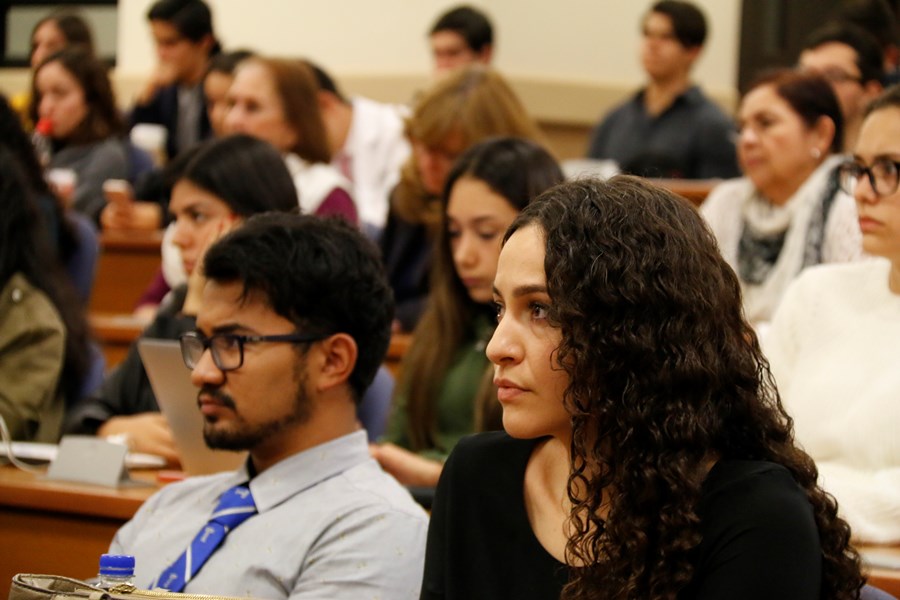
<box><xmin>0</xmin><ymin>0</ymin><xmax>740</xmax><ymax>154</ymax></box>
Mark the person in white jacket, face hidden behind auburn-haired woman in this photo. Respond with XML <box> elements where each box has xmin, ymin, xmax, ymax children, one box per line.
<box><xmin>304</xmin><ymin>60</ymin><xmax>410</xmax><ymax>240</ymax></box>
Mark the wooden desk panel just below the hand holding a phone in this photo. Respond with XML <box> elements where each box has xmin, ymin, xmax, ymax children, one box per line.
<box><xmin>90</xmin><ymin>231</ymin><xmax>163</xmax><ymax>313</ymax></box>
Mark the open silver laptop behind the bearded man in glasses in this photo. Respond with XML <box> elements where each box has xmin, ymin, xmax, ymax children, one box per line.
<box><xmin>138</xmin><ymin>338</ymin><xmax>247</xmax><ymax>475</ymax></box>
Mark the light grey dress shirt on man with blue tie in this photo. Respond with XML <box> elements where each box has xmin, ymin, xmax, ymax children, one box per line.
<box><xmin>110</xmin><ymin>431</ymin><xmax>428</xmax><ymax>600</ymax></box>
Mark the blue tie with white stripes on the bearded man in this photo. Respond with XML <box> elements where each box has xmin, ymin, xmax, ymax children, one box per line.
<box><xmin>150</xmin><ymin>483</ymin><xmax>256</xmax><ymax>592</ymax></box>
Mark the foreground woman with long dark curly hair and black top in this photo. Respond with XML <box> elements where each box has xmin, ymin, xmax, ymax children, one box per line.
<box><xmin>422</xmin><ymin>176</ymin><xmax>863</xmax><ymax>600</ymax></box>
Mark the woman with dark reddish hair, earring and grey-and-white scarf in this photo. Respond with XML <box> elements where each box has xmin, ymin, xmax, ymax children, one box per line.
<box><xmin>700</xmin><ymin>69</ymin><xmax>861</xmax><ymax>331</ymax></box>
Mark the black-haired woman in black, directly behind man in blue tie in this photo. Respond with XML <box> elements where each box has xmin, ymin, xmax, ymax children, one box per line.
<box><xmin>63</xmin><ymin>135</ymin><xmax>297</xmax><ymax>466</ymax></box>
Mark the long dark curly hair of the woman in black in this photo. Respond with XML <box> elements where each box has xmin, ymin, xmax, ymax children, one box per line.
<box><xmin>507</xmin><ymin>176</ymin><xmax>863</xmax><ymax>599</ymax></box>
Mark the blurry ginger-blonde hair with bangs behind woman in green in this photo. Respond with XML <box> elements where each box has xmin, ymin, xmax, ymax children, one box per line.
<box><xmin>391</xmin><ymin>65</ymin><xmax>543</xmax><ymax>227</ymax></box>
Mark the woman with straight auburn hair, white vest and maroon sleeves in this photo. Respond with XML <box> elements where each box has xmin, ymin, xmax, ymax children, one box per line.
<box><xmin>224</xmin><ymin>56</ymin><xmax>358</xmax><ymax>224</ymax></box>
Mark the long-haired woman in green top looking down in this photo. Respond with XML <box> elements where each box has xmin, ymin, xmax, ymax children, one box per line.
<box><xmin>374</xmin><ymin>138</ymin><xmax>563</xmax><ymax>487</ymax></box>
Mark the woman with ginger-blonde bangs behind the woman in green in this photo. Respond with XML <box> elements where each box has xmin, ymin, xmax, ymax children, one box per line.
<box><xmin>380</xmin><ymin>66</ymin><xmax>542</xmax><ymax>331</ymax></box>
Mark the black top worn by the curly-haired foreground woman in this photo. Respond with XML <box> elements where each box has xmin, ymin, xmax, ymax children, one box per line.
<box><xmin>421</xmin><ymin>432</ymin><xmax>822</xmax><ymax>600</ymax></box>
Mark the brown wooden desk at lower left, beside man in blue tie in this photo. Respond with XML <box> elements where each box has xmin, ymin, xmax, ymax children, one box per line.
<box><xmin>0</xmin><ymin>465</ymin><xmax>158</xmax><ymax>589</ymax></box>
